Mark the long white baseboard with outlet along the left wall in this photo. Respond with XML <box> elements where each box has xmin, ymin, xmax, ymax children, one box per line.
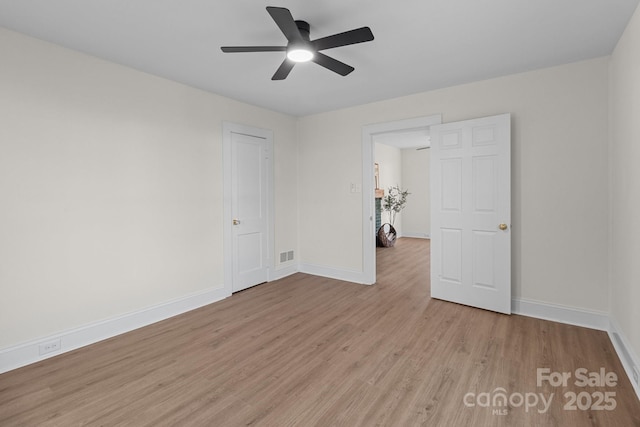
<box><xmin>0</xmin><ymin>287</ymin><xmax>231</xmax><ymax>374</ymax></box>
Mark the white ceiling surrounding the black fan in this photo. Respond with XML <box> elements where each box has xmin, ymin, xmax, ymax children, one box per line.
<box><xmin>0</xmin><ymin>0</ymin><xmax>639</xmax><ymax>116</ymax></box>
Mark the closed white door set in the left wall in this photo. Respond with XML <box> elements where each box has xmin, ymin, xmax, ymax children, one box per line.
<box><xmin>231</xmin><ymin>132</ymin><xmax>270</xmax><ymax>292</ymax></box>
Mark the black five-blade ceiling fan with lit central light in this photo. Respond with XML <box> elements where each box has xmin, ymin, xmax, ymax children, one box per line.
<box><xmin>220</xmin><ymin>6</ymin><xmax>373</xmax><ymax>80</ymax></box>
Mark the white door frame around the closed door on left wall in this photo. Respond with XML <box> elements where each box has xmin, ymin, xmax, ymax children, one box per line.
<box><xmin>222</xmin><ymin>121</ymin><xmax>275</xmax><ymax>295</ymax></box>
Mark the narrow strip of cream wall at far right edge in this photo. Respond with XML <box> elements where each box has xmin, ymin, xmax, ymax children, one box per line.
<box><xmin>610</xmin><ymin>5</ymin><xmax>640</xmax><ymax>368</ymax></box>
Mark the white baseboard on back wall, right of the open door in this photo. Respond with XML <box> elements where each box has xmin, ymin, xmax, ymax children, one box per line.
<box><xmin>511</xmin><ymin>298</ymin><xmax>609</xmax><ymax>331</ymax></box>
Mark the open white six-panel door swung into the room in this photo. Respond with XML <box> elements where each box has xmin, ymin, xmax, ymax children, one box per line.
<box><xmin>431</xmin><ymin>114</ymin><xmax>511</xmax><ymax>314</ymax></box>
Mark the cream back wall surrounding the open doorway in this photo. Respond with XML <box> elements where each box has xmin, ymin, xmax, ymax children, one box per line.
<box><xmin>298</xmin><ymin>58</ymin><xmax>608</xmax><ymax>311</ymax></box>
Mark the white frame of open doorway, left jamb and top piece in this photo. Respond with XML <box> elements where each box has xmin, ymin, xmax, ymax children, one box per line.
<box><xmin>362</xmin><ymin>114</ymin><xmax>442</xmax><ymax>285</ymax></box>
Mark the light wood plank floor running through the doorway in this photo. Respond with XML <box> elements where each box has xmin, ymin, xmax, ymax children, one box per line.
<box><xmin>0</xmin><ymin>239</ymin><xmax>640</xmax><ymax>427</ymax></box>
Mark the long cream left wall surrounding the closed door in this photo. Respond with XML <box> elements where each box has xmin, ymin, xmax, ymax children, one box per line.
<box><xmin>0</xmin><ymin>29</ymin><xmax>298</xmax><ymax>349</ymax></box>
